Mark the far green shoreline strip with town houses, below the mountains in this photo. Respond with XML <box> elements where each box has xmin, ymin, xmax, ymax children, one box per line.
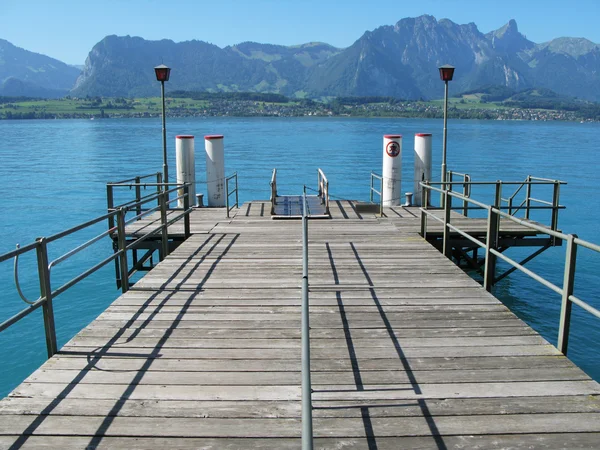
<box><xmin>0</xmin><ymin>94</ymin><xmax>598</xmax><ymax>122</ymax></box>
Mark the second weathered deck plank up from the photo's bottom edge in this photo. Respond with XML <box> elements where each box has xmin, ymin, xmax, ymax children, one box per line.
<box><xmin>0</xmin><ymin>413</ymin><xmax>600</xmax><ymax>438</ymax></box>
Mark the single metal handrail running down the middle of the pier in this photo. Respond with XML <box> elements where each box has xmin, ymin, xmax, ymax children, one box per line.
<box><xmin>301</xmin><ymin>186</ymin><xmax>313</xmax><ymax>450</ymax></box>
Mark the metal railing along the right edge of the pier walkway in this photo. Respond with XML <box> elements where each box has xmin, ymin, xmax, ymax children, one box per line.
<box><xmin>420</xmin><ymin>183</ymin><xmax>600</xmax><ymax>355</ymax></box>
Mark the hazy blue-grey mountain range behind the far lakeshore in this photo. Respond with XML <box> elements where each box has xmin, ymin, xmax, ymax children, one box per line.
<box><xmin>0</xmin><ymin>15</ymin><xmax>600</xmax><ymax>101</ymax></box>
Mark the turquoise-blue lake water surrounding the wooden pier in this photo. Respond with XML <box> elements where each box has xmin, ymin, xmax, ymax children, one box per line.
<box><xmin>0</xmin><ymin>118</ymin><xmax>600</xmax><ymax>396</ymax></box>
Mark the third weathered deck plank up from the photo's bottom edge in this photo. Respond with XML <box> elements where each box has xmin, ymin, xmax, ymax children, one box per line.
<box><xmin>0</xmin><ymin>395</ymin><xmax>600</xmax><ymax>418</ymax></box>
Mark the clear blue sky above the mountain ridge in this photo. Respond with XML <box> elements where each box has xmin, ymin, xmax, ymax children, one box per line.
<box><xmin>0</xmin><ymin>0</ymin><xmax>600</xmax><ymax>64</ymax></box>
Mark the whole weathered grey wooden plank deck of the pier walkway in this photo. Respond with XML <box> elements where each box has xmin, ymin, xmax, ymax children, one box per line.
<box><xmin>0</xmin><ymin>201</ymin><xmax>600</xmax><ymax>449</ymax></box>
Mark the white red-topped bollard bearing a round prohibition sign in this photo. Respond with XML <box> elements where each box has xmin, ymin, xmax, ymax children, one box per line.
<box><xmin>381</xmin><ymin>134</ymin><xmax>402</xmax><ymax>206</ymax></box>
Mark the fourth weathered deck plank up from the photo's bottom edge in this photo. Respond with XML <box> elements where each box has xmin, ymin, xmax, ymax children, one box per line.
<box><xmin>10</xmin><ymin>380</ymin><xmax>600</xmax><ymax>405</ymax></box>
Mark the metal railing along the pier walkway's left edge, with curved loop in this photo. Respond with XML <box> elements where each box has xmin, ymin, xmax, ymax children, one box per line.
<box><xmin>0</xmin><ymin>183</ymin><xmax>191</xmax><ymax>357</ymax></box>
